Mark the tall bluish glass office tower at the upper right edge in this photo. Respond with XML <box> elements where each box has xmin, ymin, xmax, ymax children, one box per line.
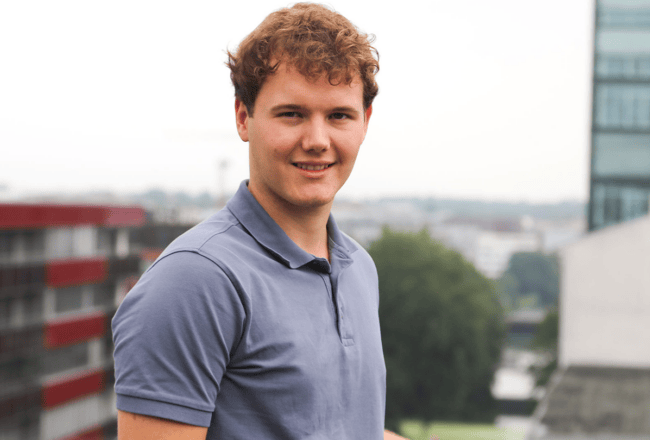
<box><xmin>589</xmin><ymin>0</ymin><xmax>650</xmax><ymax>230</ymax></box>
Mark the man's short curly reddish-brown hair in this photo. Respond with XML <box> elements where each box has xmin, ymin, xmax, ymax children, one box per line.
<box><xmin>226</xmin><ymin>3</ymin><xmax>379</xmax><ymax>116</ymax></box>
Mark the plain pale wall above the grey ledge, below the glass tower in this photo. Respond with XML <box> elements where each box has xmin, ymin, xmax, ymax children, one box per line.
<box><xmin>558</xmin><ymin>217</ymin><xmax>650</xmax><ymax>368</ymax></box>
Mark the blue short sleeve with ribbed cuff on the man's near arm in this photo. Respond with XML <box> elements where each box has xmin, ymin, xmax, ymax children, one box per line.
<box><xmin>112</xmin><ymin>251</ymin><xmax>245</xmax><ymax>427</ymax></box>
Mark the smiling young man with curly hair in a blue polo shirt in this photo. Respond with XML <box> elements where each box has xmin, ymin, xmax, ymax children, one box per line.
<box><xmin>113</xmin><ymin>4</ymin><xmax>393</xmax><ymax>440</ymax></box>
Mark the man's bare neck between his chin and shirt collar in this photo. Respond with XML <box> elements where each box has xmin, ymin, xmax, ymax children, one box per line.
<box><xmin>251</xmin><ymin>192</ymin><xmax>332</xmax><ymax>260</ymax></box>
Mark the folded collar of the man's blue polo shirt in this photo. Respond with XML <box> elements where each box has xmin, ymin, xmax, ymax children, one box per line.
<box><xmin>227</xmin><ymin>180</ymin><xmax>358</xmax><ymax>269</ymax></box>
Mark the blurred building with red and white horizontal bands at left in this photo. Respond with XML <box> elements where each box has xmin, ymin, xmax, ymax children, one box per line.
<box><xmin>0</xmin><ymin>204</ymin><xmax>145</xmax><ymax>440</ymax></box>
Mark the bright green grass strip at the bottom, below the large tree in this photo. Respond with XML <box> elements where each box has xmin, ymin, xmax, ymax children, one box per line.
<box><xmin>401</xmin><ymin>421</ymin><xmax>524</xmax><ymax>440</ymax></box>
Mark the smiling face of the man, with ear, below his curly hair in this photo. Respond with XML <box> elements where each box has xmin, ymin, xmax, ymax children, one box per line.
<box><xmin>235</xmin><ymin>63</ymin><xmax>372</xmax><ymax>215</ymax></box>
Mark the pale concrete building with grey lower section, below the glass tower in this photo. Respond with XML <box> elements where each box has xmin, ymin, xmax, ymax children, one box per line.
<box><xmin>531</xmin><ymin>216</ymin><xmax>650</xmax><ymax>440</ymax></box>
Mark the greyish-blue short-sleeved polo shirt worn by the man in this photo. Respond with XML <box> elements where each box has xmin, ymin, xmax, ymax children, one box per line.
<box><xmin>112</xmin><ymin>182</ymin><xmax>386</xmax><ymax>440</ymax></box>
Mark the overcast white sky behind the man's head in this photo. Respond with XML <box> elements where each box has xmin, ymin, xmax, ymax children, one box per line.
<box><xmin>0</xmin><ymin>0</ymin><xmax>593</xmax><ymax>202</ymax></box>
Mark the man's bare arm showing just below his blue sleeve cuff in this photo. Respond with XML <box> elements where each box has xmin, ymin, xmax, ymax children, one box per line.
<box><xmin>117</xmin><ymin>411</ymin><xmax>208</xmax><ymax>440</ymax></box>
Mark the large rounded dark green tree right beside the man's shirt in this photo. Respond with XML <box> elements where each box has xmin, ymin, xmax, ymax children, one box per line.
<box><xmin>369</xmin><ymin>229</ymin><xmax>504</xmax><ymax>430</ymax></box>
